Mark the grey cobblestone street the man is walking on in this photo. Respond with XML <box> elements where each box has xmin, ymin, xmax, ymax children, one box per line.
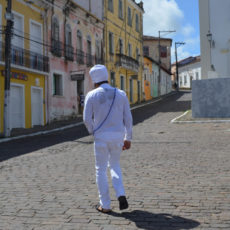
<box><xmin>0</xmin><ymin>92</ymin><xmax>230</xmax><ymax>230</ymax></box>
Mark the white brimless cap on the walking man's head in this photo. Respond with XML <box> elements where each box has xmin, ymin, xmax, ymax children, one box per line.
<box><xmin>89</xmin><ymin>65</ymin><xmax>108</xmax><ymax>83</ymax></box>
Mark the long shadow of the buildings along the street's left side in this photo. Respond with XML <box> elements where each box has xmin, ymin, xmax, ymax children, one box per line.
<box><xmin>0</xmin><ymin>92</ymin><xmax>191</xmax><ymax>162</ymax></box>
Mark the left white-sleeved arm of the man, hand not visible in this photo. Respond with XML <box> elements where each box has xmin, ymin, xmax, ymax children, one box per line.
<box><xmin>83</xmin><ymin>95</ymin><xmax>93</xmax><ymax>134</ymax></box>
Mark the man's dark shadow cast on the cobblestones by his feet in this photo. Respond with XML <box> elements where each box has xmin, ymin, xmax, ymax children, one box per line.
<box><xmin>110</xmin><ymin>210</ymin><xmax>200</xmax><ymax>230</ymax></box>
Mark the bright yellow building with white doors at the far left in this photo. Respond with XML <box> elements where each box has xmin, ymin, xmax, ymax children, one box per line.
<box><xmin>0</xmin><ymin>0</ymin><xmax>49</xmax><ymax>133</ymax></box>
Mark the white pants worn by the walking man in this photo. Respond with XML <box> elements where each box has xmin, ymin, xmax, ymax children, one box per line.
<box><xmin>94</xmin><ymin>140</ymin><xmax>125</xmax><ymax>209</ymax></box>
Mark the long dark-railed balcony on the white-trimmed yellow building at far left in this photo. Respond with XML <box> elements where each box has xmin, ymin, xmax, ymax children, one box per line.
<box><xmin>0</xmin><ymin>42</ymin><xmax>49</xmax><ymax>72</ymax></box>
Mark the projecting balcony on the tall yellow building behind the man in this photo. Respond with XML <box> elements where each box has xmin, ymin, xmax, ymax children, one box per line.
<box><xmin>116</xmin><ymin>53</ymin><xmax>139</xmax><ymax>72</ymax></box>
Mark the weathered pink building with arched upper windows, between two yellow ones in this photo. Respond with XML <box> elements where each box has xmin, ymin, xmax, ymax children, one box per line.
<box><xmin>47</xmin><ymin>1</ymin><xmax>104</xmax><ymax>122</ymax></box>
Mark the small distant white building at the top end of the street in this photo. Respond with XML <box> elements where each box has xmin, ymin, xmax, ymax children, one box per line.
<box><xmin>178</xmin><ymin>56</ymin><xmax>201</xmax><ymax>89</ymax></box>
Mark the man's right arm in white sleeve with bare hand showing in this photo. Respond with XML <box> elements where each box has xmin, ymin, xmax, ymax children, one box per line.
<box><xmin>123</xmin><ymin>97</ymin><xmax>133</xmax><ymax>150</ymax></box>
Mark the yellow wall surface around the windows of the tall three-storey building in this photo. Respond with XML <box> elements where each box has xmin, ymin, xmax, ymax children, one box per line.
<box><xmin>104</xmin><ymin>0</ymin><xmax>143</xmax><ymax>104</ymax></box>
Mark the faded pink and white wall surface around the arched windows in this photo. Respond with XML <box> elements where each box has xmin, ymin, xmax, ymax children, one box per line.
<box><xmin>48</xmin><ymin>0</ymin><xmax>104</xmax><ymax>121</ymax></box>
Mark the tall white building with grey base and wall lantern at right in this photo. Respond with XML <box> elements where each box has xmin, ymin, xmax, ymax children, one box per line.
<box><xmin>192</xmin><ymin>0</ymin><xmax>230</xmax><ymax>118</ymax></box>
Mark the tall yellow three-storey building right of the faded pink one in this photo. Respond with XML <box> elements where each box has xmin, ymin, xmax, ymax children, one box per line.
<box><xmin>104</xmin><ymin>0</ymin><xmax>144</xmax><ymax>104</ymax></box>
